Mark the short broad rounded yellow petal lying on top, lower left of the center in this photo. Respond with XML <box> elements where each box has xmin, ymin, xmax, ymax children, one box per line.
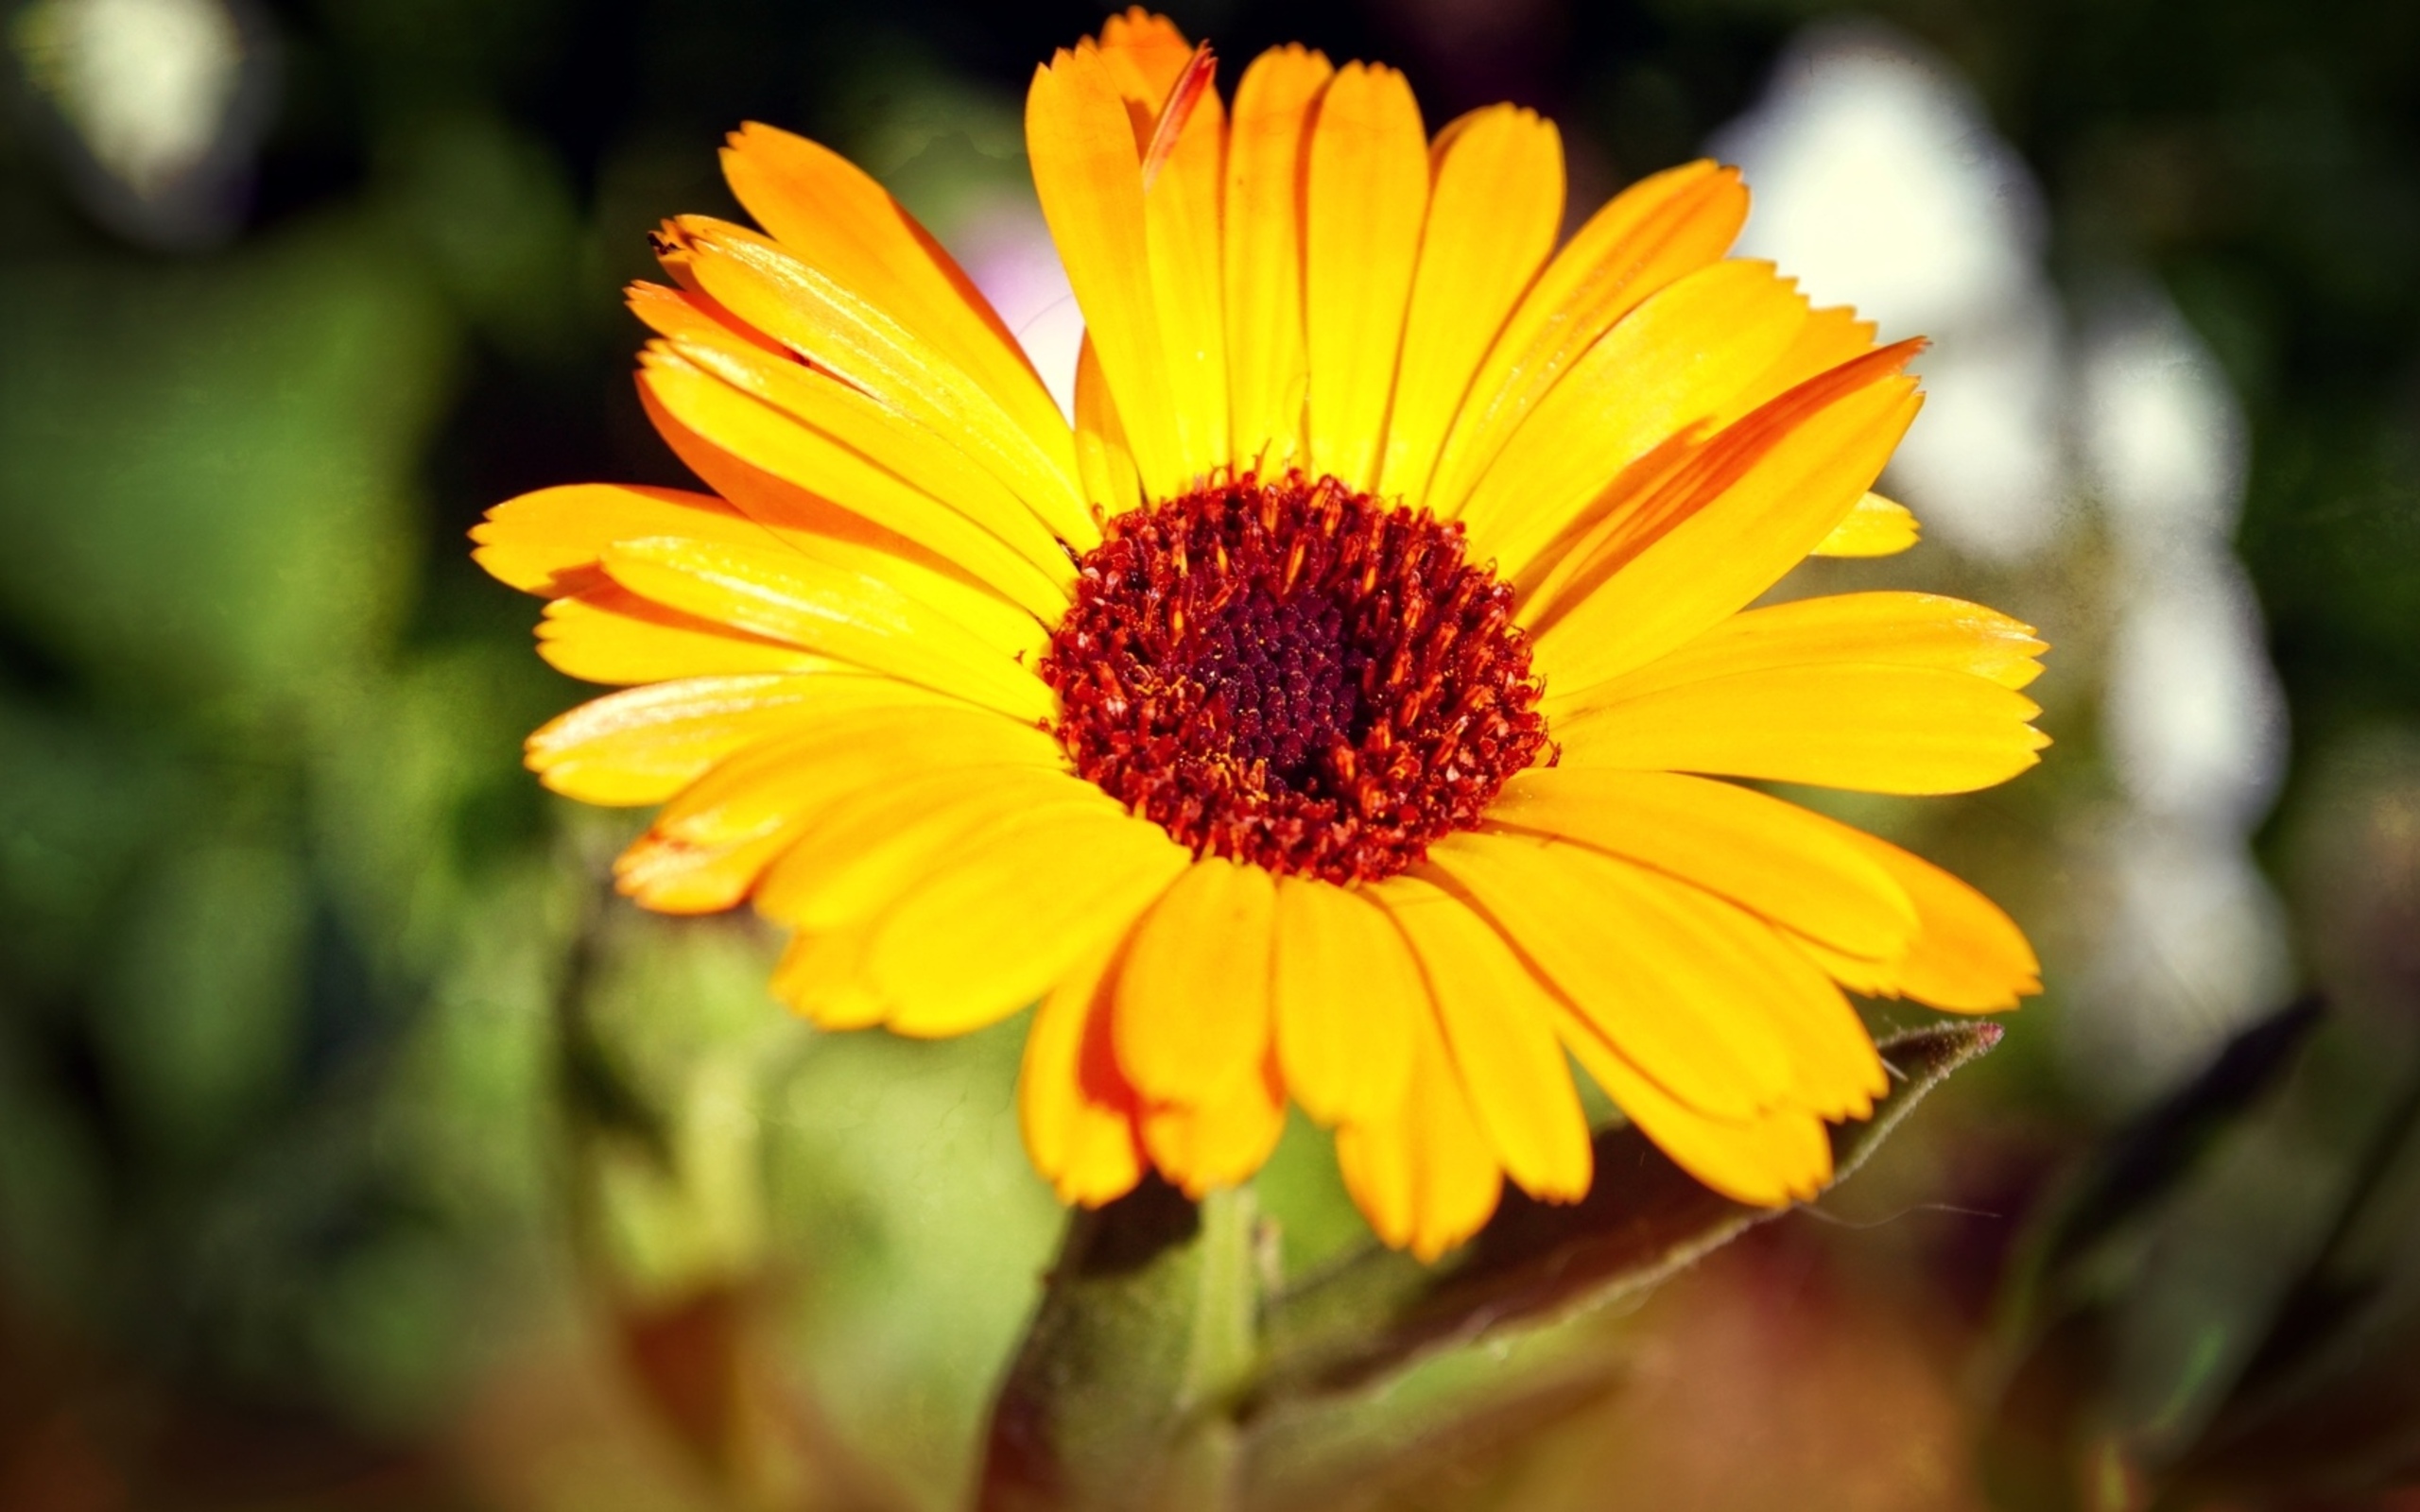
<box><xmin>866</xmin><ymin>808</ymin><xmax>1193</xmax><ymax>1036</ymax></box>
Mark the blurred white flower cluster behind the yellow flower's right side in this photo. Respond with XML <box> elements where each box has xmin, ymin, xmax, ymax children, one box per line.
<box><xmin>1713</xmin><ymin>25</ymin><xmax>2291</xmax><ymax>1103</ymax></box>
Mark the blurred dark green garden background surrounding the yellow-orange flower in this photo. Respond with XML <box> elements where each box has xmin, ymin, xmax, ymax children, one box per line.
<box><xmin>0</xmin><ymin>0</ymin><xmax>2420</xmax><ymax>1512</ymax></box>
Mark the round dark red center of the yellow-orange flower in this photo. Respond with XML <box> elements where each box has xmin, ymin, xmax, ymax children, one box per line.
<box><xmin>1041</xmin><ymin>472</ymin><xmax>1547</xmax><ymax>883</ymax></box>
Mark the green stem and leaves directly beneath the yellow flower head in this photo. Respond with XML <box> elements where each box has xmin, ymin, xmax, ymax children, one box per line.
<box><xmin>977</xmin><ymin>1023</ymin><xmax>2001</xmax><ymax>1512</ymax></box>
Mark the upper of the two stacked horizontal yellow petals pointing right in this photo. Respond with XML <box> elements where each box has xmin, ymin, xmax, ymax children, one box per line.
<box><xmin>1542</xmin><ymin>593</ymin><xmax>2048</xmax><ymax>721</ymax></box>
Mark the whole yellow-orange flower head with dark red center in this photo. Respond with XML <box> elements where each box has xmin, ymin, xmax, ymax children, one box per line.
<box><xmin>475</xmin><ymin>9</ymin><xmax>2045</xmax><ymax>1256</ymax></box>
